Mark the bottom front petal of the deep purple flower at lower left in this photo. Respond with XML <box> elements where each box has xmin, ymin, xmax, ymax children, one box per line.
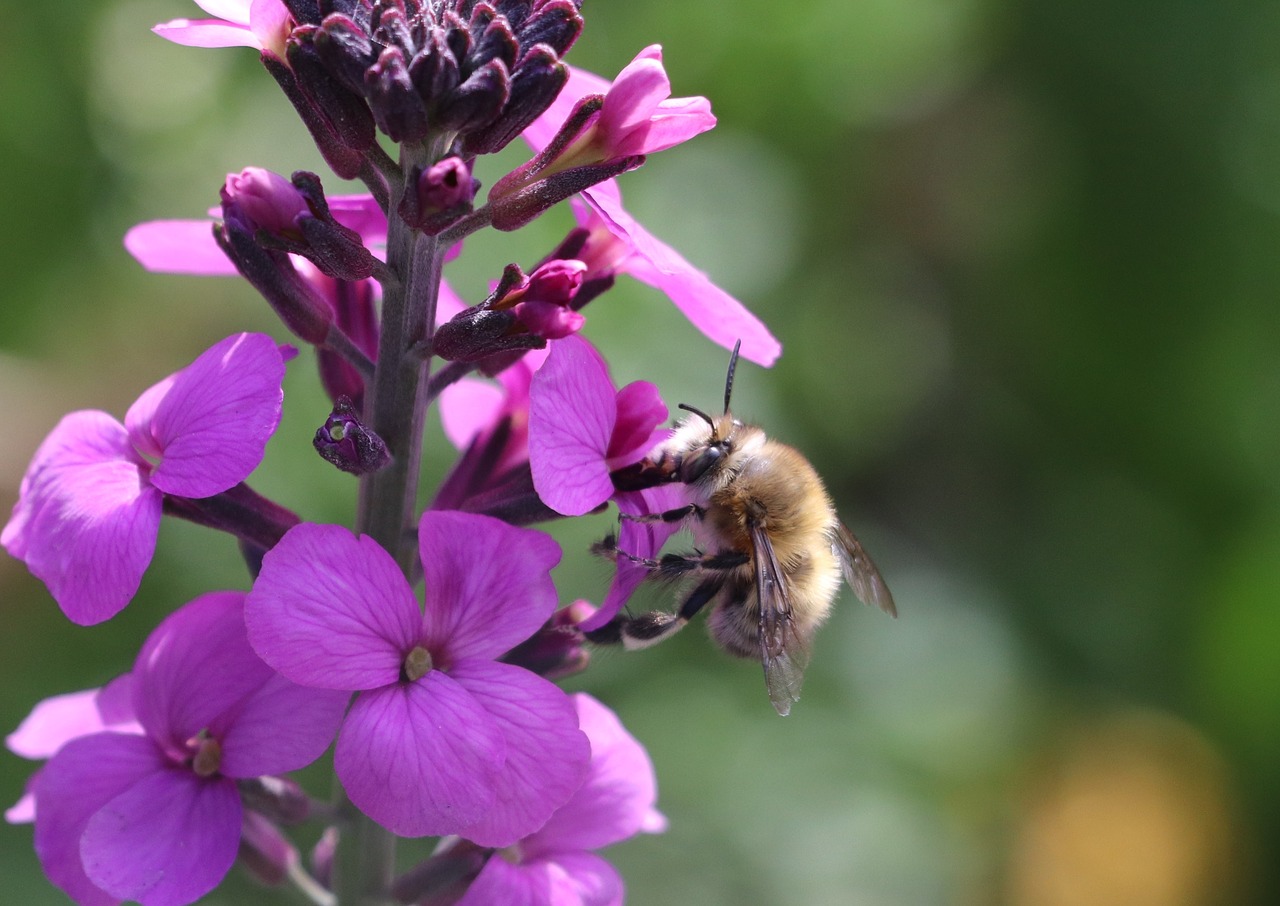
<box><xmin>81</xmin><ymin>770</ymin><xmax>242</xmax><ymax>906</ymax></box>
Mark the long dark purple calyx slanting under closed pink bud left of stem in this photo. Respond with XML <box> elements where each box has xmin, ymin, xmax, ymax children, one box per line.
<box><xmin>214</xmin><ymin>219</ymin><xmax>333</xmax><ymax>346</ymax></box>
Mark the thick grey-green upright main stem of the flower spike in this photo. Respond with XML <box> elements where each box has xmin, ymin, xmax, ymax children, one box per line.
<box><xmin>334</xmin><ymin>136</ymin><xmax>448</xmax><ymax>906</ymax></box>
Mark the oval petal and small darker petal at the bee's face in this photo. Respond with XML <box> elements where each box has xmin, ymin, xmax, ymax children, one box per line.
<box><xmin>529</xmin><ymin>337</ymin><xmax>667</xmax><ymax>516</ymax></box>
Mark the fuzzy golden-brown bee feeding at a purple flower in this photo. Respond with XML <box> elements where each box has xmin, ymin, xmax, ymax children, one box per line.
<box><xmin>586</xmin><ymin>344</ymin><xmax>897</xmax><ymax>715</ymax></box>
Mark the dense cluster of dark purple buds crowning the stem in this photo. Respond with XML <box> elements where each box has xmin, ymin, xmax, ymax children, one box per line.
<box><xmin>279</xmin><ymin>0</ymin><xmax>582</xmax><ymax>152</ymax></box>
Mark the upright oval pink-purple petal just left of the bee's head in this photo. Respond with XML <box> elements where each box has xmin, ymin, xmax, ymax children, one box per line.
<box><xmin>529</xmin><ymin>337</ymin><xmax>617</xmax><ymax>516</ymax></box>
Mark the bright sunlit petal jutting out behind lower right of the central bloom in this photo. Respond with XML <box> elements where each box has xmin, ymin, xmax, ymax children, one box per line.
<box><xmin>524</xmin><ymin>692</ymin><xmax>658</xmax><ymax>855</ymax></box>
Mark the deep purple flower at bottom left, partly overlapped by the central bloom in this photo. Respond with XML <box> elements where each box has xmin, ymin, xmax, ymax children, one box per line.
<box><xmin>35</xmin><ymin>591</ymin><xmax>347</xmax><ymax>906</ymax></box>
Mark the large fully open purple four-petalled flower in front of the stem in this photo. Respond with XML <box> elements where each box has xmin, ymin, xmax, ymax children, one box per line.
<box><xmin>246</xmin><ymin>511</ymin><xmax>589</xmax><ymax>846</ymax></box>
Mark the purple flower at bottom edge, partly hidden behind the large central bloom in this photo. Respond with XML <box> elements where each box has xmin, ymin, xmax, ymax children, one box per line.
<box><xmin>457</xmin><ymin>692</ymin><xmax>667</xmax><ymax>906</ymax></box>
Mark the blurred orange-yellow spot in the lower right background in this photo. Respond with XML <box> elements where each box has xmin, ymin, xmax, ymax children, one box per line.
<box><xmin>1007</xmin><ymin>713</ymin><xmax>1240</xmax><ymax>906</ymax></box>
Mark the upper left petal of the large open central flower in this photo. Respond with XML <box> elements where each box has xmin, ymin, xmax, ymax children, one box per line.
<box><xmin>244</xmin><ymin>522</ymin><xmax>422</xmax><ymax>691</ymax></box>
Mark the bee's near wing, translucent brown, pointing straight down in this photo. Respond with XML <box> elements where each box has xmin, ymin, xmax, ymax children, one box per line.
<box><xmin>750</xmin><ymin>525</ymin><xmax>809</xmax><ymax>717</ymax></box>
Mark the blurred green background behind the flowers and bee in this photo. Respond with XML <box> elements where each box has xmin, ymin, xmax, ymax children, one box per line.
<box><xmin>0</xmin><ymin>0</ymin><xmax>1280</xmax><ymax>906</ymax></box>
